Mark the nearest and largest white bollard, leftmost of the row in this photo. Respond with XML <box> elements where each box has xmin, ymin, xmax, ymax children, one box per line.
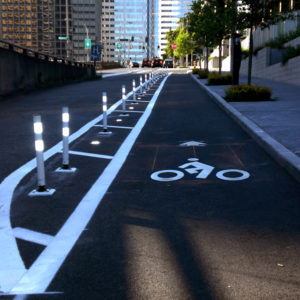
<box><xmin>29</xmin><ymin>115</ymin><xmax>55</xmax><ymax>196</ymax></box>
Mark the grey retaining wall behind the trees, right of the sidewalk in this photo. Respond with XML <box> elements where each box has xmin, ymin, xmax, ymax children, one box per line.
<box><xmin>240</xmin><ymin>48</ymin><xmax>300</xmax><ymax>85</ymax></box>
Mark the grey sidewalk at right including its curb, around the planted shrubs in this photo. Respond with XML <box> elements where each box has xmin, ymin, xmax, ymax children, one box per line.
<box><xmin>191</xmin><ymin>75</ymin><xmax>300</xmax><ymax>181</ymax></box>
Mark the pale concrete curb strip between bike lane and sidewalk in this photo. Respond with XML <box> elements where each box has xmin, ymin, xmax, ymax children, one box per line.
<box><xmin>190</xmin><ymin>73</ymin><xmax>300</xmax><ymax>182</ymax></box>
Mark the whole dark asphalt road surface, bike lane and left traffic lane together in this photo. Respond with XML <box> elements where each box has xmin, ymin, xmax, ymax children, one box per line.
<box><xmin>0</xmin><ymin>74</ymin><xmax>300</xmax><ymax>300</ymax></box>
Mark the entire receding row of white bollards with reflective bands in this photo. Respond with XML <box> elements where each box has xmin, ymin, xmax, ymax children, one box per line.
<box><xmin>29</xmin><ymin>72</ymin><xmax>165</xmax><ymax>196</ymax></box>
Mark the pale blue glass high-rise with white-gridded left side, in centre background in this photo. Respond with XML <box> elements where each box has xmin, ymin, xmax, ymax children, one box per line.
<box><xmin>101</xmin><ymin>0</ymin><xmax>152</xmax><ymax>64</ymax></box>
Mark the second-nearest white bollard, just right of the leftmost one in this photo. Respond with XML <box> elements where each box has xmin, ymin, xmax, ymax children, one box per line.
<box><xmin>56</xmin><ymin>106</ymin><xmax>76</xmax><ymax>173</ymax></box>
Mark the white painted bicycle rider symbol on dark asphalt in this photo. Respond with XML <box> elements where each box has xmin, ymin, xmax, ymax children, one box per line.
<box><xmin>151</xmin><ymin>158</ymin><xmax>250</xmax><ymax>181</ymax></box>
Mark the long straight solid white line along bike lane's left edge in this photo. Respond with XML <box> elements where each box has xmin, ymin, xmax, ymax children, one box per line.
<box><xmin>10</xmin><ymin>76</ymin><xmax>169</xmax><ymax>294</ymax></box>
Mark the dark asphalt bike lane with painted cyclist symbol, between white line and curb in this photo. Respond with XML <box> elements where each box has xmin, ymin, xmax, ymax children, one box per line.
<box><xmin>48</xmin><ymin>74</ymin><xmax>300</xmax><ymax>299</ymax></box>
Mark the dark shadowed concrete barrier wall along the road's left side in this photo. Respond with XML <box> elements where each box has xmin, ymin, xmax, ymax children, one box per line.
<box><xmin>0</xmin><ymin>43</ymin><xmax>95</xmax><ymax>96</ymax></box>
